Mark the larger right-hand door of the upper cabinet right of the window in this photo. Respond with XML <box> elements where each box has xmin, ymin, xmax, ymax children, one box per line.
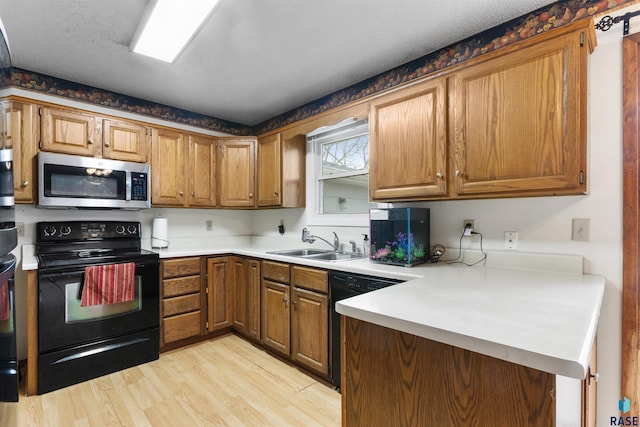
<box><xmin>449</xmin><ymin>33</ymin><xmax>589</xmax><ymax>197</ymax></box>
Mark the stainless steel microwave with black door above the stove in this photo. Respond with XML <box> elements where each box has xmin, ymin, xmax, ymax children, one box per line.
<box><xmin>38</xmin><ymin>152</ymin><xmax>151</xmax><ymax>209</ymax></box>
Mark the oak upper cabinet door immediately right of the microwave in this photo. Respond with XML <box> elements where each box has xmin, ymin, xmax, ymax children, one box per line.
<box><xmin>151</xmin><ymin>129</ymin><xmax>188</xmax><ymax>206</ymax></box>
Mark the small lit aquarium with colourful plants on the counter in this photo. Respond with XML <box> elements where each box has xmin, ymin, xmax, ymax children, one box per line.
<box><xmin>369</xmin><ymin>208</ymin><xmax>430</xmax><ymax>267</ymax></box>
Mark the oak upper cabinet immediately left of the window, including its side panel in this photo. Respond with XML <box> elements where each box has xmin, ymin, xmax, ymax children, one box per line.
<box><xmin>256</xmin><ymin>133</ymin><xmax>306</xmax><ymax>208</ymax></box>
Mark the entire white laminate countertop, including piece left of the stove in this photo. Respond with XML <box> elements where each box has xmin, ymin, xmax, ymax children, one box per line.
<box><xmin>22</xmin><ymin>237</ymin><xmax>605</xmax><ymax>379</ymax></box>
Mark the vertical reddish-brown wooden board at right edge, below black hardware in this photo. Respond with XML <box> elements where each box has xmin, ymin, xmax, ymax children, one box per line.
<box><xmin>620</xmin><ymin>34</ymin><xmax>640</xmax><ymax>413</ymax></box>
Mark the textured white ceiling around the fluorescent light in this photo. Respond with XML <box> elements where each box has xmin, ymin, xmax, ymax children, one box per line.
<box><xmin>0</xmin><ymin>0</ymin><xmax>554</xmax><ymax>125</ymax></box>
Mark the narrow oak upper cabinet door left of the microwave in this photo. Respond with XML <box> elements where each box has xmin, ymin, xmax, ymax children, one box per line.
<box><xmin>4</xmin><ymin>101</ymin><xmax>38</xmax><ymax>203</ymax></box>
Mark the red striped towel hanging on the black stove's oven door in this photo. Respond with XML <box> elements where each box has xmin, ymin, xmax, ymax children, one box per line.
<box><xmin>80</xmin><ymin>262</ymin><xmax>136</xmax><ymax>307</ymax></box>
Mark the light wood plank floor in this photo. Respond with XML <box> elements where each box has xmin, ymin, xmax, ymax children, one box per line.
<box><xmin>0</xmin><ymin>335</ymin><xmax>340</xmax><ymax>427</ymax></box>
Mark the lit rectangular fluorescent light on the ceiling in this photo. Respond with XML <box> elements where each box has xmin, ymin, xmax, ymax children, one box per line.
<box><xmin>132</xmin><ymin>0</ymin><xmax>218</xmax><ymax>62</ymax></box>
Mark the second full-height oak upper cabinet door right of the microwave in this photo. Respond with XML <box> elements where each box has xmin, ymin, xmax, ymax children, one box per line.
<box><xmin>189</xmin><ymin>135</ymin><xmax>216</xmax><ymax>207</ymax></box>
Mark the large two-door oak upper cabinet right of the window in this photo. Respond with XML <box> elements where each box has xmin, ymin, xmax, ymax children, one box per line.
<box><xmin>369</xmin><ymin>20</ymin><xmax>595</xmax><ymax>201</ymax></box>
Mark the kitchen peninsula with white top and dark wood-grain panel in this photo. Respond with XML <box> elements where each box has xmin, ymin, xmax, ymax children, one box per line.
<box><xmin>336</xmin><ymin>260</ymin><xmax>604</xmax><ymax>426</ymax></box>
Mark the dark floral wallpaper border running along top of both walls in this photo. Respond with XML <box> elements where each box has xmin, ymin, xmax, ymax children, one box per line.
<box><xmin>3</xmin><ymin>0</ymin><xmax>634</xmax><ymax>135</ymax></box>
